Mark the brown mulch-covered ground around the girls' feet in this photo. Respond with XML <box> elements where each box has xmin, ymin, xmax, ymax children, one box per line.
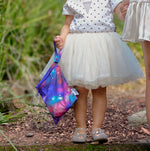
<box><xmin>0</xmin><ymin>80</ymin><xmax>150</xmax><ymax>146</ymax></box>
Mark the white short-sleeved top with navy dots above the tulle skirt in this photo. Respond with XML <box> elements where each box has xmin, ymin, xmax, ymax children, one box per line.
<box><xmin>62</xmin><ymin>0</ymin><xmax>122</xmax><ymax>33</ymax></box>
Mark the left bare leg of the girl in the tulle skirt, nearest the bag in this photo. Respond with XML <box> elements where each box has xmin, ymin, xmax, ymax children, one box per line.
<box><xmin>74</xmin><ymin>87</ymin><xmax>89</xmax><ymax>128</ymax></box>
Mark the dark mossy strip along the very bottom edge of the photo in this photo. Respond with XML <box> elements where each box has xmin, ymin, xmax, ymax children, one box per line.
<box><xmin>0</xmin><ymin>143</ymin><xmax>150</xmax><ymax>151</ymax></box>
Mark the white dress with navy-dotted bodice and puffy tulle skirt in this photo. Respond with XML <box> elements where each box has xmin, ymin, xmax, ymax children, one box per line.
<box><xmin>41</xmin><ymin>0</ymin><xmax>143</xmax><ymax>89</ymax></box>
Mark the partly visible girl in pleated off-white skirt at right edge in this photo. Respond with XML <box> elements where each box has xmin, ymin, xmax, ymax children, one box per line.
<box><xmin>122</xmin><ymin>0</ymin><xmax>150</xmax><ymax>126</ymax></box>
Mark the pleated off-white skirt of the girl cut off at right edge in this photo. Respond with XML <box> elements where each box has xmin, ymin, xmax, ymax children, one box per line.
<box><xmin>122</xmin><ymin>0</ymin><xmax>150</xmax><ymax>42</ymax></box>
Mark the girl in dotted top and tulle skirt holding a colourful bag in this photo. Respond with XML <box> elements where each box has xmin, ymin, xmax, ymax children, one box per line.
<box><xmin>43</xmin><ymin>0</ymin><xmax>142</xmax><ymax>142</ymax></box>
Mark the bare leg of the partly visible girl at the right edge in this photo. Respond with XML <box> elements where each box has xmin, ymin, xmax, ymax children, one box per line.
<box><xmin>142</xmin><ymin>41</ymin><xmax>150</xmax><ymax>127</ymax></box>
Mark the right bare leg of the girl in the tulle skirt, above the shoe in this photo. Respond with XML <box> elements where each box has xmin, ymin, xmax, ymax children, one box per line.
<box><xmin>92</xmin><ymin>87</ymin><xmax>107</xmax><ymax>129</ymax></box>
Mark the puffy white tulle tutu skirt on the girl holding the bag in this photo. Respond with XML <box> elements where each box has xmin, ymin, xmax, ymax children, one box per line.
<box><xmin>41</xmin><ymin>32</ymin><xmax>143</xmax><ymax>89</ymax></box>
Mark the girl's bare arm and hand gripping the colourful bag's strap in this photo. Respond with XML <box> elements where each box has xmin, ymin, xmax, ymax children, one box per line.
<box><xmin>54</xmin><ymin>15</ymin><xmax>73</xmax><ymax>49</ymax></box>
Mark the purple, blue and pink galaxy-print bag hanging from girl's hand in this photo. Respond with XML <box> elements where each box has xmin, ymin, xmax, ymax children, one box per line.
<box><xmin>36</xmin><ymin>42</ymin><xmax>78</xmax><ymax>124</ymax></box>
